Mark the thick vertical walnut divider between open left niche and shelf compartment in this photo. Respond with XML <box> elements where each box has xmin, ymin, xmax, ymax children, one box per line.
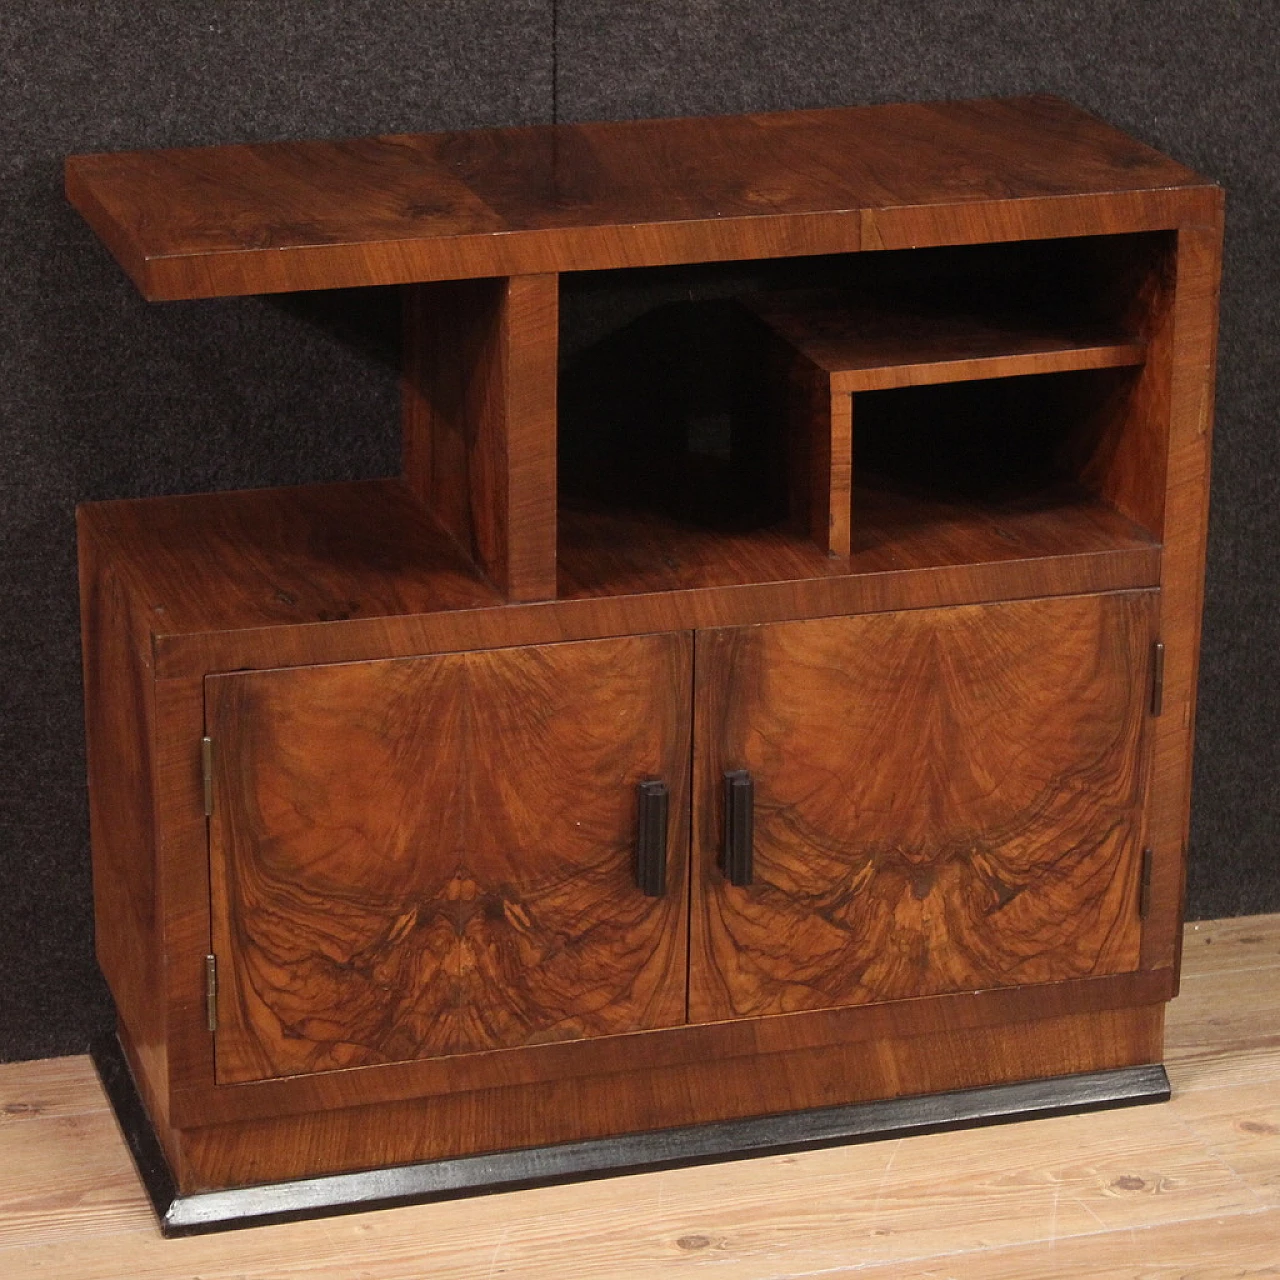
<box><xmin>402</xmin><ymin>274</ymin><xmax>559</xmax><ymax>600</ymax></box>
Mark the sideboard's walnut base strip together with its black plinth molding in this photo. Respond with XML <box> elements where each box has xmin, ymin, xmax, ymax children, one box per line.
<box><xmin>95</xmin><ymin>988</ymin><xmax>1170</xmax><ymax>1235</ymax></box>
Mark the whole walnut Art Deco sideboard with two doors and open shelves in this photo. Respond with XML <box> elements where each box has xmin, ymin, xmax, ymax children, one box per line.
<box><xmin>67</xmin><ymin>97</ymin><xmax>1222</xmax><ymax>1233</ymax></box>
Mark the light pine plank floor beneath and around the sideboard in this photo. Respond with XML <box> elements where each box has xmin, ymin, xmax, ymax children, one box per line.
<box><xmin>0</xmin><ymin>915</ymin><xmax>1280</xmax><ymax>1280</ymax></box>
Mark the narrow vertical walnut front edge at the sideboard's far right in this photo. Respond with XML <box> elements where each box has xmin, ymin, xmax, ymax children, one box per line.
<box><xmin>1142</xmin><ymin>215</ymin><xmax>1222</xmax><ymax>968</ymax></box>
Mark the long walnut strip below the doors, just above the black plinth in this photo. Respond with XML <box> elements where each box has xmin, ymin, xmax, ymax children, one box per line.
<box><xmin>182</xmin><ymin>1005</ymin><xmax>1165</xmax><ymax>1192</ymax></box>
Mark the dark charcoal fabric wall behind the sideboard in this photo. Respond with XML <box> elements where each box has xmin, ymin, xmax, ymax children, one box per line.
<box><xmin>0</xmin><ymin>0</ymin><xmax>1280</xmax><ymax>1060</ymax></box>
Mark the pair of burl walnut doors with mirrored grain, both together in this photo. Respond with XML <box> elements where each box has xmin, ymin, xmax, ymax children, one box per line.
<box><xmin>205</xmin><ymin>591</ymin><xmax>1157</xmax><ymax>1085</ymax></box>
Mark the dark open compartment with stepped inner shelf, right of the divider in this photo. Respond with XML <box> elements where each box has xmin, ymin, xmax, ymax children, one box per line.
<box><xmin>558</xmin><ymin>233</ymin><xmax>1171</xmax><ymax>595</ymax></box>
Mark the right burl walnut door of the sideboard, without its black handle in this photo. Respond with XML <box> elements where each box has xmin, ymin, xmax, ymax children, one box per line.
<box><xmin>690</xmin><ymin>591</ymin><xmax>1157</xmax><ymax>1020</ymax></box>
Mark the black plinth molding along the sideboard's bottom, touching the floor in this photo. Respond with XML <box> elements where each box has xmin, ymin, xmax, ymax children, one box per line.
<box><xmin>92</xmin><ymin>1036</ymin><xmax>1169</xmax><ymax>1235</ymax></box>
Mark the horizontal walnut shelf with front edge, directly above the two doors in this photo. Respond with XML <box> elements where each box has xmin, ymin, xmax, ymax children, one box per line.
<box><xmin>82</xmin><ymin>480</ymin><xmax>1161</xmax><ymax>678</ymax></box>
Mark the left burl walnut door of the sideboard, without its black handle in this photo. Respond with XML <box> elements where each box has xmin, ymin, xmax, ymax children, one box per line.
<box><xmin>205</xmin><ymin>632</ymin><xmax>691</xmax><ymax>1083</ymax></box>
